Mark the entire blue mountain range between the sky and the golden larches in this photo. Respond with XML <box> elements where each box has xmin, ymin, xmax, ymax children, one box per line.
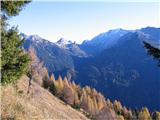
<box><xmin>21</xmin><ymin>27</ymin><xmax>160</xmax><ymax>110</ymax></box>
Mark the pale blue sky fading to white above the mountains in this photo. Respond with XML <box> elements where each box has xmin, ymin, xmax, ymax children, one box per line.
<box><xmin>9</xmin><ymin>0</ymin><xmax>160</xmax><ymax>43</ymax></box>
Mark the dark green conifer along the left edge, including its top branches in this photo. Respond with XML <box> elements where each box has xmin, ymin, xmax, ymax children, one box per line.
<box><xmin>0</xmin><ymin>1</ymin><xmax>30</xmax><ymax>84</ymax></box>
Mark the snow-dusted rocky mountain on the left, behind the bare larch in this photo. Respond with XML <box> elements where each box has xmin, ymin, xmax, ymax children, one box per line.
<box><xmin>21</xmin><ymin>34</ymin><xmax>87</xmax><ymax>77</ymax></box>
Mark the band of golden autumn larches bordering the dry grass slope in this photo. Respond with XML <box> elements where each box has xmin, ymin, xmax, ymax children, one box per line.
<box><xmin>25</xmin><ymin>48</ymin><xmax>160</xmax><ymax>120</ymax></box>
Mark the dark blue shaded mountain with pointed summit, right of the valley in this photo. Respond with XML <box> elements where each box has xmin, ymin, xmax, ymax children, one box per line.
<box><xmin>77</xmin><ymin>33</ymin><xmax>160</xmax><ymax>110</ymax></box>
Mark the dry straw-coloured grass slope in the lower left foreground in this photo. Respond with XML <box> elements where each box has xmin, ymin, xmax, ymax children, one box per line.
<box><xmin>1</xmin><ymin>76</ymin><xmax>88</xmax><ymax>120</ymax></box>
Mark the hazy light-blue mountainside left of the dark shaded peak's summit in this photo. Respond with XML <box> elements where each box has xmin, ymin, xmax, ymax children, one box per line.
<box><xmin>80</xmin><ymin>29</ymin><xmax>131</xmax><ymax>55</ymax></box>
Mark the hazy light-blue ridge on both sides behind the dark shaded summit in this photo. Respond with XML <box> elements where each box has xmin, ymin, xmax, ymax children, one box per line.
<box><xmin>80</xmin><ymin>27</ymin><xmax>160</xmax><ymax>55</ymax></box>
